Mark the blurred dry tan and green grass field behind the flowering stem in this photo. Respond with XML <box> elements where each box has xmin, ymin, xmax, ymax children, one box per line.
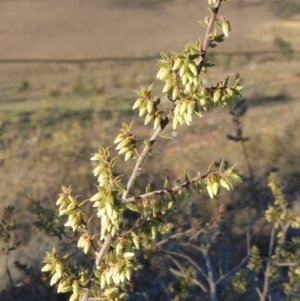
<box><xmin>0</xmin><ymin>0</ymin><xmax>300</xmax><ymax>296</ymax></box>
